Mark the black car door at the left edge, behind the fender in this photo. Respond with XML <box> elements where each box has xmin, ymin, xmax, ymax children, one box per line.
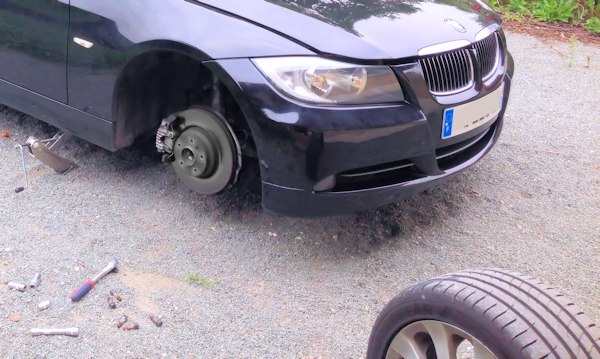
<box><xmin>0</xmin><ymin>0</ymin><xmax>69</xmax><ymax>103</ymax></box>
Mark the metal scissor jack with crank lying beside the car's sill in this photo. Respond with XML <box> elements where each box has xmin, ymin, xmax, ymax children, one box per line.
<box><xmin>15</xmin><ymin>131</ymin><xmax>78</xmax><ymax>193</ymax></box>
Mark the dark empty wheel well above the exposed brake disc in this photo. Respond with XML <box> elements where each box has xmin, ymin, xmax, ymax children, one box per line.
<box><xmin>112</xmin><ymin>41</ymin><xmax>256</xmax><ymax>158</ymax></box>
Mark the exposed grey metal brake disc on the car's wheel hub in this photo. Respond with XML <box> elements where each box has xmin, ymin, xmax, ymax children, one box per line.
<box><xmin>172</xmin><ymin>109</ymin><xmax>242</xmax><ymax>194</ymax></box>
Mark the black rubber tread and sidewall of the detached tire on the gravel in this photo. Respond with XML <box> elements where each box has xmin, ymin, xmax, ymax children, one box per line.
<box><xmin>367</xmin><ymin>269</ymin><xmax>600</xmax><ymax>359</ymax></box>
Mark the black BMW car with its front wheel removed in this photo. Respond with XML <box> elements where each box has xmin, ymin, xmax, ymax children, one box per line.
<box><xmin>0</xmin><ymin>0</ymin><xmax>514</xmax><ymax>216</ymax></box>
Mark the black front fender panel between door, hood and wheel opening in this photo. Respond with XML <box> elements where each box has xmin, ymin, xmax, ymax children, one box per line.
<box><xmin>67</xmin><ymin>0</ymin><xmax>314</xmax><ymax>149</ymax></box>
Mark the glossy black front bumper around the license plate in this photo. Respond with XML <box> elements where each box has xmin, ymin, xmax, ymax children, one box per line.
<box><xmin>210</xmin><ymin>49</ymin><xmax>513</xmax><ymax>217</ymax></box>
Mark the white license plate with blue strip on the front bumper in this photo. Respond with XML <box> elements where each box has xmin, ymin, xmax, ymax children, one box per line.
<box><xmin>442</xmin><ymin>85</ymin><xmax>504</xmax><ymax>139</ymax></box>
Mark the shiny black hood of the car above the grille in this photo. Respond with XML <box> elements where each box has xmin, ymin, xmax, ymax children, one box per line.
<box><xmin>193</xmin><ymin>0</ymin><xmax>500</xmax><ymax>60</ymax></box>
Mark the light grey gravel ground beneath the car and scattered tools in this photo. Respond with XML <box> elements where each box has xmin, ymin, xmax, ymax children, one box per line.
<box><xmin>0</xmin><ymin>34</ymin><xmax>600</xmax><ymax>358</ymax></box>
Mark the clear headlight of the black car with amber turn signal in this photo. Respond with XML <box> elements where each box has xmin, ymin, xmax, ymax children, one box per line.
<box><xmin>253</xmin><ymin>57</ymin><xmax>404</xmax><ymax>104</ymax></box>
